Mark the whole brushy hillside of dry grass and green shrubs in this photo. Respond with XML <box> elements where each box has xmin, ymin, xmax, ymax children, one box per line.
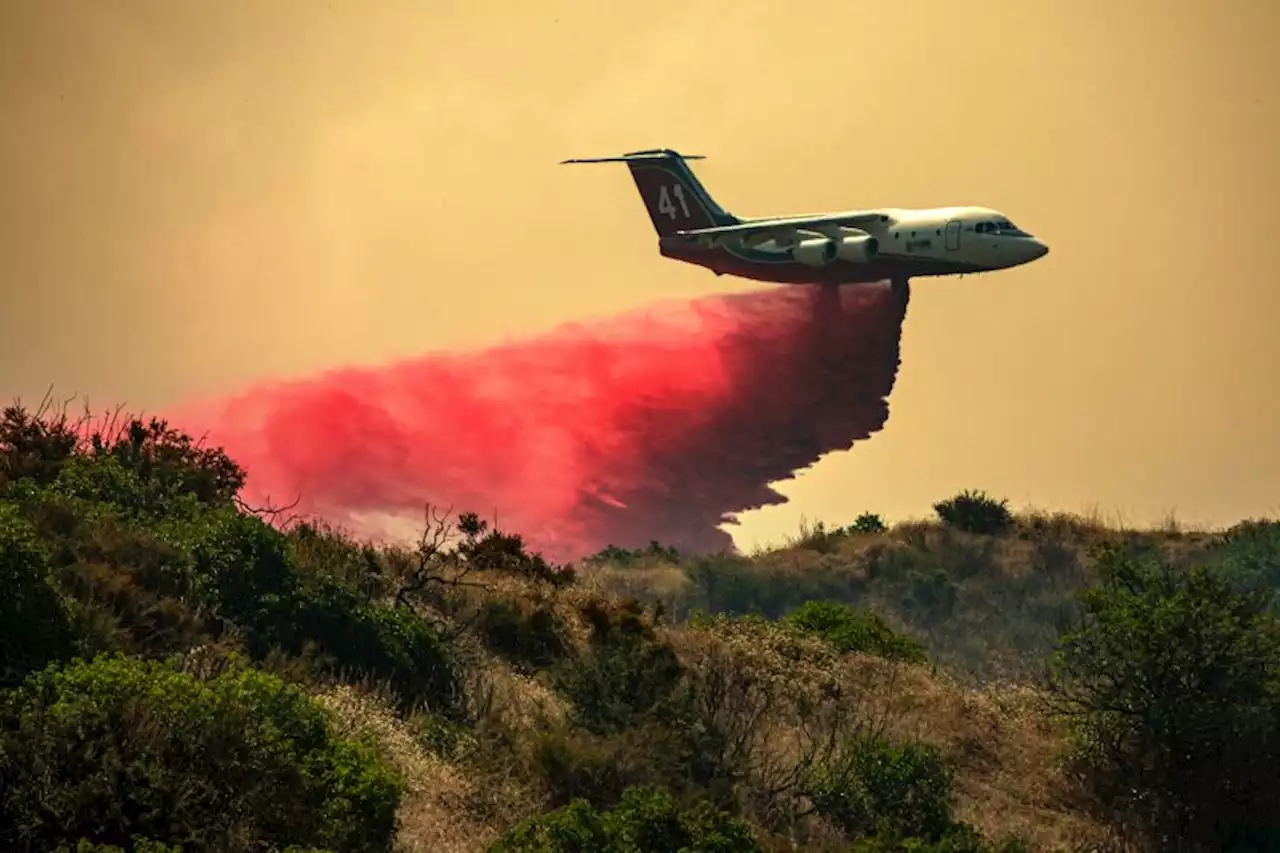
<box><xmin>0</xmin><ymin>407</ymin><xmax>1280</xmax><ymax>853</ymax></box>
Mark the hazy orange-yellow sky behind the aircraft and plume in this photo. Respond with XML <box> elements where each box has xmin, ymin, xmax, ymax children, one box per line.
<box><xmin>0</xmin><ymin>0</ymin><xmax>1280</xmax><ymax>547</ymax></box>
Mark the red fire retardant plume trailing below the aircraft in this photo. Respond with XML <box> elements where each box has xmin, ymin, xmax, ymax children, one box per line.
<box><xmin>169</xmin><ymin>283</ymin><xmax>909</xmax><ymax>560</ymax></box>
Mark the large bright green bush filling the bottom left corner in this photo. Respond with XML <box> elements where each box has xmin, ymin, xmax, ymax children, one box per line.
<box><xmin>0</xmin><ymin>656</ymin><xmax>401</xmax><ymax>852</ymax></box>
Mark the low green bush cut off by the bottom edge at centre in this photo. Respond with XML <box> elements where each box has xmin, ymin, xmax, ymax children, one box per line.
<box><xmin>489</xmin><ymin>788</ymin><xmax>763</xmax><ymax>853</ymax></box>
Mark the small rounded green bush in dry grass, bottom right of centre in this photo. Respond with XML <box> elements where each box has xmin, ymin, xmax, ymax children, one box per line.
<box><xmin>805</xmin><ymin>736</ymin><xmax>955</xmax><ymax>841</ymax></box>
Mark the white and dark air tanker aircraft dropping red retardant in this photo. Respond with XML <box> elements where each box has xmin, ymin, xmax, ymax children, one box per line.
<box><xmin>562</xmin><ymin>149</ymin><xmax>1048</xmax><ymax>284</ymax></box>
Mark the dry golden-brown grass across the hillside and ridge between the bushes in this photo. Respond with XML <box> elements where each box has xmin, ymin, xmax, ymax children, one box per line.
<box><xmin>304</xmin><ymin>512</ymin><xmax>1244</xmax><ymax>853</ymax></box>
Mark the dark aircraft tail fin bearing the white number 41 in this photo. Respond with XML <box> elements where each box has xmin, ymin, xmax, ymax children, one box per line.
<box><xmin>561</xmin><ymin>149</ymin><xmax>739</xmax><ymax>237</ymax></box>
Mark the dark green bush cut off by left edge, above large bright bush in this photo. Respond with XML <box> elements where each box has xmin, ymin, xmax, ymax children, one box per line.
<box><xmin>0</xmin><ymin>502</ymin><xmax>73</xmax><ymax>686</ymax></box>
